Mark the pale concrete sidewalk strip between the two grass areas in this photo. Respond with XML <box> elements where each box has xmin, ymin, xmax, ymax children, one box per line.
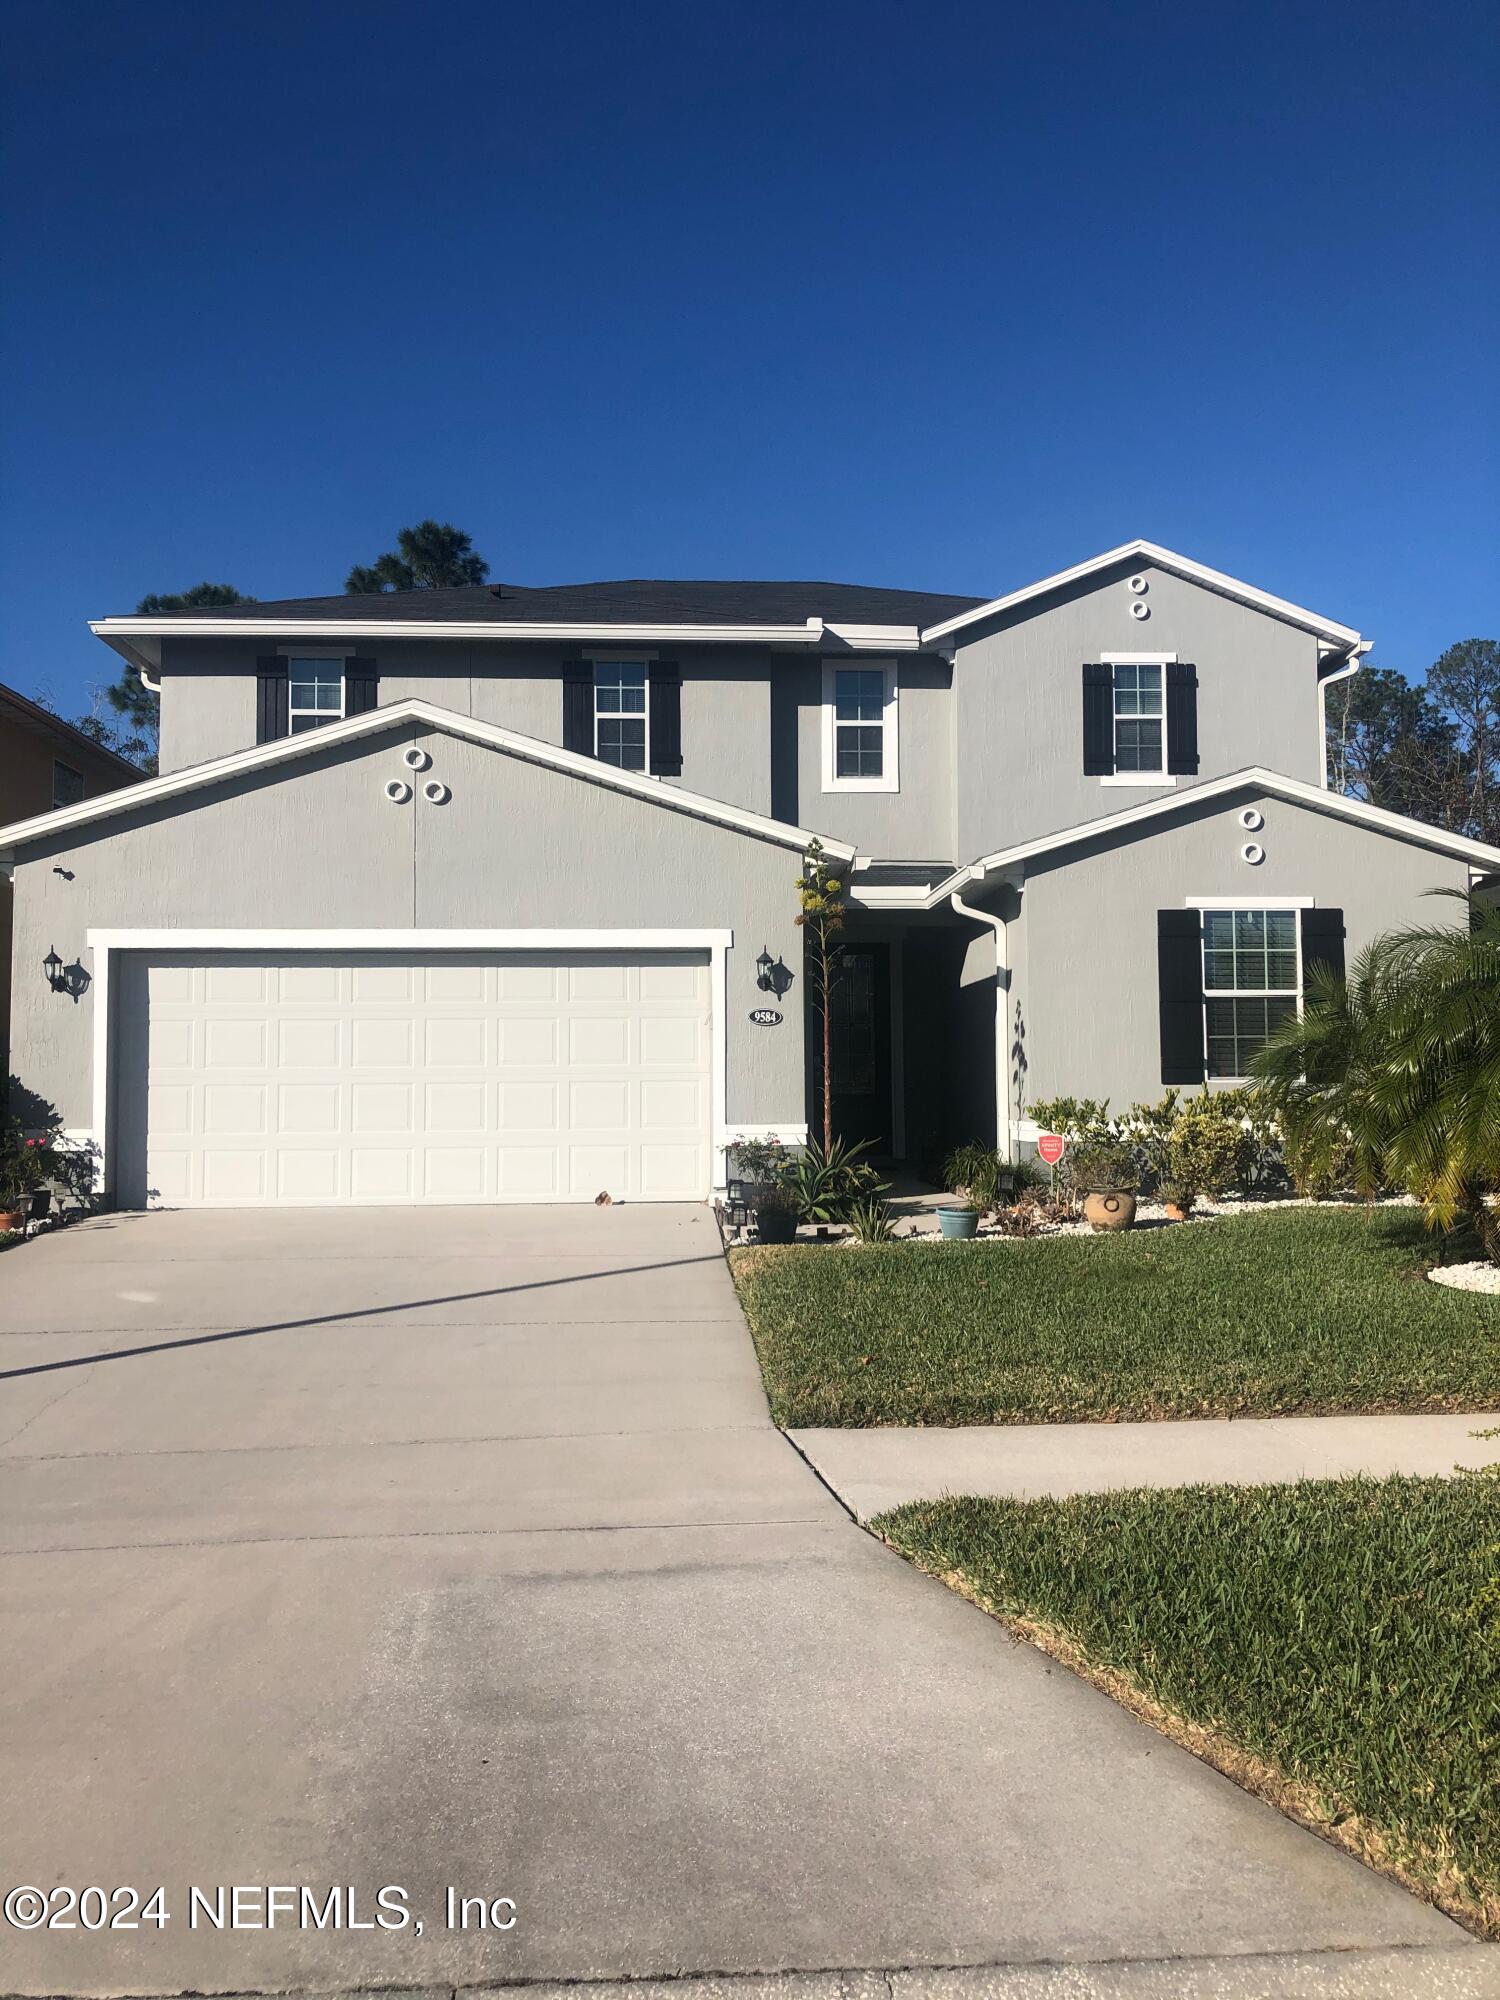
<box><xmin>788</xmin><ymin>1412</ymin><xmax>1500</xmax><ymax>1520</ymax></box>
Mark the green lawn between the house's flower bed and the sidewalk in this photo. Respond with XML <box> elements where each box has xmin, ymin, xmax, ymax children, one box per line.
<box><xmin>730</xmin><ymin>1208</ymin><xmax>1500</xmax><ymax>1426</ymax></box>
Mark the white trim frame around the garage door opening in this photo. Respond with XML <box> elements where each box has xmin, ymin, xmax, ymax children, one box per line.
<box><xmin>86</xmin><ymin>930</ymin><xmax>734</xmax><ymax>1192</ymax></box>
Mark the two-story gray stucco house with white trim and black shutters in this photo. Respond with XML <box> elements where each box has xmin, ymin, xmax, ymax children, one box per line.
<box><xmin>0</xmin><ymin>542</ymin><xmax>1500</xmax><ymax>1204</ymax></box>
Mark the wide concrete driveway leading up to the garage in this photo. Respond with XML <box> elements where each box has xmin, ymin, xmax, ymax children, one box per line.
<box><xmin>0</xmin><ymin>1206</ymin><xmax>1470</xmax><ymax>1994</ymax></box>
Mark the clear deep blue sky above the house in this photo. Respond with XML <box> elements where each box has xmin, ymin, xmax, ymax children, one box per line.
<box><xmin>0</xmin><ymin>0</ymin><xmax>1500</xmax><ymax>712</ymax></box>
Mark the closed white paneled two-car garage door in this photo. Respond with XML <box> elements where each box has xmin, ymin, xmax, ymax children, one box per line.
<box><xmin>146</xmin><ymin>952</ymin><xmax>712</xmax><ymax>1206</ymax></box>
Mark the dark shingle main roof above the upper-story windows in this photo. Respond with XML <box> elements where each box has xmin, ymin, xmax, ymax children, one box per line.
<box><xmin>126</xmin><ymin>578</ymin><xmax>988</xmax><ymax>626</ymax></box>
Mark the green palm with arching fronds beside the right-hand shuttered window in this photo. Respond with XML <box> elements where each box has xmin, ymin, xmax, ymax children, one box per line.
<box><xmin>1254</xmin><ymin>890</ymin><xmax>1500</xmax><ymax>1264</ymax></box>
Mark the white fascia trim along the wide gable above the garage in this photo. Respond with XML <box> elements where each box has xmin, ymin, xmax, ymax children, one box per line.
<box><xmin>0</xmin><ymin>696</ymin><xmax>854</xmax><ymax>862</ymax></box>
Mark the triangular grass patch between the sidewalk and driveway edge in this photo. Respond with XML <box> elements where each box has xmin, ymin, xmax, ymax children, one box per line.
<box><xmin>874</xmin><ymin>1474</ymin><xmax>1500</xmax><ymax>1936</ymax></box>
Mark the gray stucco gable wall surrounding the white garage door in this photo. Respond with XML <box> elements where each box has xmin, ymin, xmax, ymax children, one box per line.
<box><xmin>12</xmin><ymin>722</ymin><xmax>806</xmax><ymax>1152</ymax></box>
